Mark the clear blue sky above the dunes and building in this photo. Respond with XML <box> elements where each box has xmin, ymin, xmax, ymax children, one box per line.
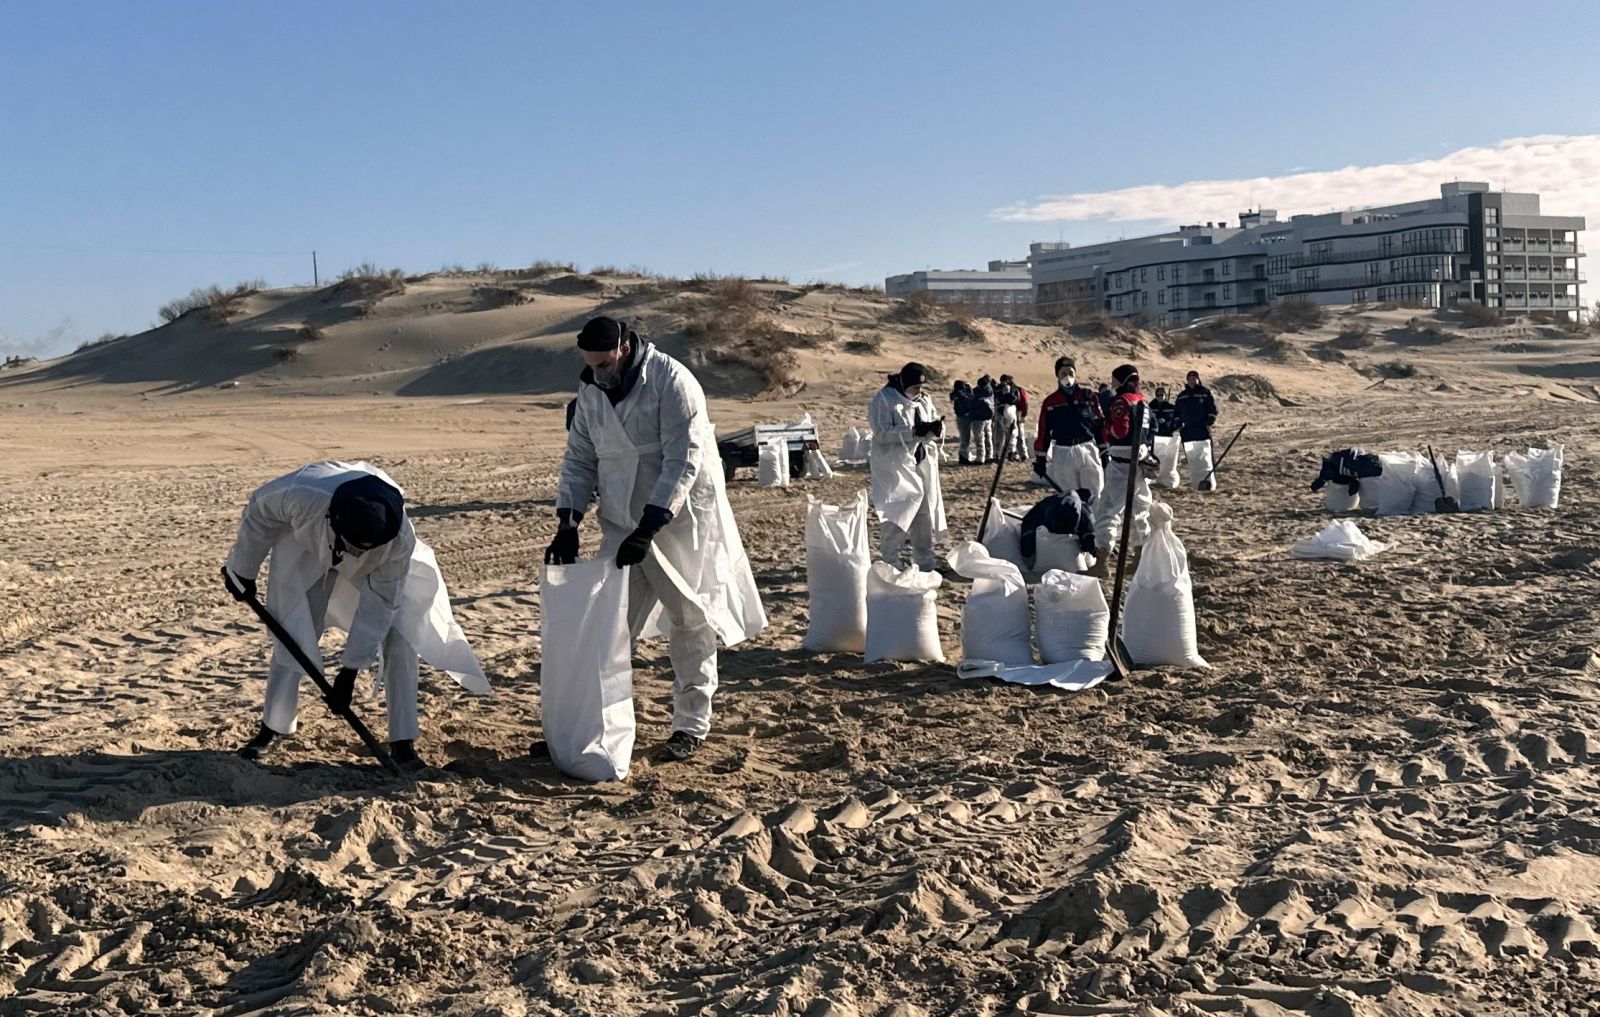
<box><xmin>0</xmin><ymin>0</ymin><xmax>1600</xmax><ymax>353</ymax></box>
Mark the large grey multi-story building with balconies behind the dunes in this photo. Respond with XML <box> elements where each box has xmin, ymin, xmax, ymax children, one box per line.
<box><xmin>1029</xmin><ymin>182</ymin><xmax>1584</xmax><ymax>325</ymax></box>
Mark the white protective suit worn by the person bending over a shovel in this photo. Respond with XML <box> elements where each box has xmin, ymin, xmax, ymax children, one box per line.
<box><xmin>227</xmin><ymin>462</ymin><xmax>490</xmax><ymax>742</ymax></box>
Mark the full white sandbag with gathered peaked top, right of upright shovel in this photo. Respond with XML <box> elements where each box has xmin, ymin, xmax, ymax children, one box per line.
<box><xmin>1122</xmin><ymin>502</ymin><xmax>1211</xmax><ymax>667</ymax></box>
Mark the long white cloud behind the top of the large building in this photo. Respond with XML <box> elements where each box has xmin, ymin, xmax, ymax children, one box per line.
<box><xmin>994</xmin><ymin>134</ymin><xmax>1600</xmax><ymax>227</ymax></box>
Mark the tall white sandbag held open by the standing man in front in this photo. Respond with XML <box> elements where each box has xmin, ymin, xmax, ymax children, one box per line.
<box><xmin>539</xmin><ymin>558</ymin><xmax>634</xmax><ymax>780</ymax></box>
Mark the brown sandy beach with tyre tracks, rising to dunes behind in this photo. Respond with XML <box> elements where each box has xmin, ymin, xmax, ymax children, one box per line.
<box><xmin>0</xmin><ymin>273</ymin><xmax>1600</xmax><ymax>1017</ymax></box>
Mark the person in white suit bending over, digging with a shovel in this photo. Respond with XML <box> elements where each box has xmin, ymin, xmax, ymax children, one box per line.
<box><xmin>222</xmin><ymin>462</ymin><xmax>490</xmax><ymax>771</ymax></box>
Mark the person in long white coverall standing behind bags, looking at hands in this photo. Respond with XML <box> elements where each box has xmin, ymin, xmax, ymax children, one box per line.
<box><xmin>867</xmin><ymin>363</ymin><xmax>946</xmax><ymax>571</ymax></box>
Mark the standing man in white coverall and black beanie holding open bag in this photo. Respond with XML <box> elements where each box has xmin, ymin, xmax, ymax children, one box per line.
<box><xmin>544</xmin><ymin>317</ymin><xmax>766</xmax><ymax>760</ymax></box>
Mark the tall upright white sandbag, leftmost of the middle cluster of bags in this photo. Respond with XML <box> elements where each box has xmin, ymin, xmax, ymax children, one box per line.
<box><xmin>802</xmin><ymin>491</ymin><xmax>872</xmax><ymax>654</ymax></box>
